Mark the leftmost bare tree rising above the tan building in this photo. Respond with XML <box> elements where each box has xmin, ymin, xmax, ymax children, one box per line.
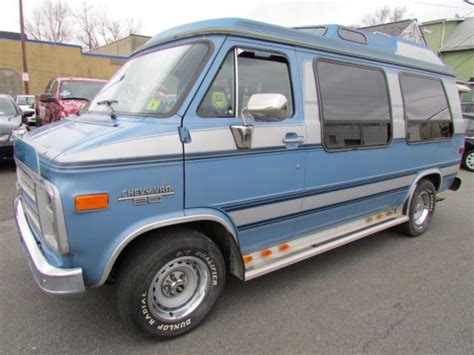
<box><xmin>25</xmin><ymin>0</ymin><xmax>72</xmax><ymax>43</ymax></box>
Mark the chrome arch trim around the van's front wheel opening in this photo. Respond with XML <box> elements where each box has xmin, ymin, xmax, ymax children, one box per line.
<box><xmin>94</xmin><ymin>214</ymin><xmax>239</xmax><ymax>287</ymax></box>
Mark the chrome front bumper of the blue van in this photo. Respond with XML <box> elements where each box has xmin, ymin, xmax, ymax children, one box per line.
<box><xmin>14</xmin><ymin>197</ymin><xmax>85</xmax><ymax>296</ymax></box>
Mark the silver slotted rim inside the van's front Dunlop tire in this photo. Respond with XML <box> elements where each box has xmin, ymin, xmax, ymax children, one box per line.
<box><xmin>148</xmin><ymin>256</ymin><xmax>210</xmax><ymax>321</ymax></box>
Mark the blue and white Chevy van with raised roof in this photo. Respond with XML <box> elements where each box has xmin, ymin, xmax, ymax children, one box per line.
<box><xmin>15</xmin><ymin>19</ymin><xmax>464</xmax><ymax>338</ymax></box>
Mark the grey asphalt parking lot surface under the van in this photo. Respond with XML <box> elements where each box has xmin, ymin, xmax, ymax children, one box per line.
<box><xmin>0</xmin><ymin>161</ymin><xmax>474</xmax><ymax>354</ymax></box>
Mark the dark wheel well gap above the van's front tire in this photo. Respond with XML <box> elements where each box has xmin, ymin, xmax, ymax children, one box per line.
<box><xmin>107</xmin><ymin>221</ymin><xmax>244</xmax><ymax>282</ymax></box>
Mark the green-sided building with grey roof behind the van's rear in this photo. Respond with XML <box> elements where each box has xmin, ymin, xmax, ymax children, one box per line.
<box><xmin>422</xmin><ymin>17</ymin><xmax>474</xmax><ymax>81</ymax></box>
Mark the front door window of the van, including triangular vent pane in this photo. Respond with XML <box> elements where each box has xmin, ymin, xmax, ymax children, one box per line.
<box><xmin>197</xmin><ymin>49</ymin><xmax>293</xmax><ymax>117</ymax></box>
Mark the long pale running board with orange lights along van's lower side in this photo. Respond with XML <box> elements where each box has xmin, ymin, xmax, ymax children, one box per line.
<box><xmin>245</xmin><ymin>216</ymin><xmax>408</xmax><ymax>281</ymax></box>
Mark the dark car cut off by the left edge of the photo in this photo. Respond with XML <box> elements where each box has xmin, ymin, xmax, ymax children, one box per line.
<box><xmin>0</xmin><ymin>94</ymin><xmax>33</xmax><ymax>159</ymax></box>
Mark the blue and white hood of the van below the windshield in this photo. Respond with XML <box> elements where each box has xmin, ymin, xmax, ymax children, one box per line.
<box><xmin>15</xmin><ymin>114</ymin><xmax>182</xmax><ymax>171</ymax></box>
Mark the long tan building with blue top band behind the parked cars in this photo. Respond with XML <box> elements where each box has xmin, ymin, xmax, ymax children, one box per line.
<box><xmin>0</xmin><ymin>32</ymin><xmax>126</xmax><ymax>96</ymax></box>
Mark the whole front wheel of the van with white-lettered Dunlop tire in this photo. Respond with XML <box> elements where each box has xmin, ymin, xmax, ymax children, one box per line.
<box><xmin>117</xmin><ymin>228</ymin><xmax>226</xmax><ymax>340</ymax></box>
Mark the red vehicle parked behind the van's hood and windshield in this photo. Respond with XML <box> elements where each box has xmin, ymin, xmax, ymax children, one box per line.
<box><xmin>36</xmin><ymin>78</ymin><xmax>106</xmax><ymax>126</ymax></box>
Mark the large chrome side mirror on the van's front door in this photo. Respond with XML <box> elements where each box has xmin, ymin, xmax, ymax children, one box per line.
<box><xmin>247</xmin><ymin>94</ymin><xmax>288</xmax><ymax>121</ymax></box>
